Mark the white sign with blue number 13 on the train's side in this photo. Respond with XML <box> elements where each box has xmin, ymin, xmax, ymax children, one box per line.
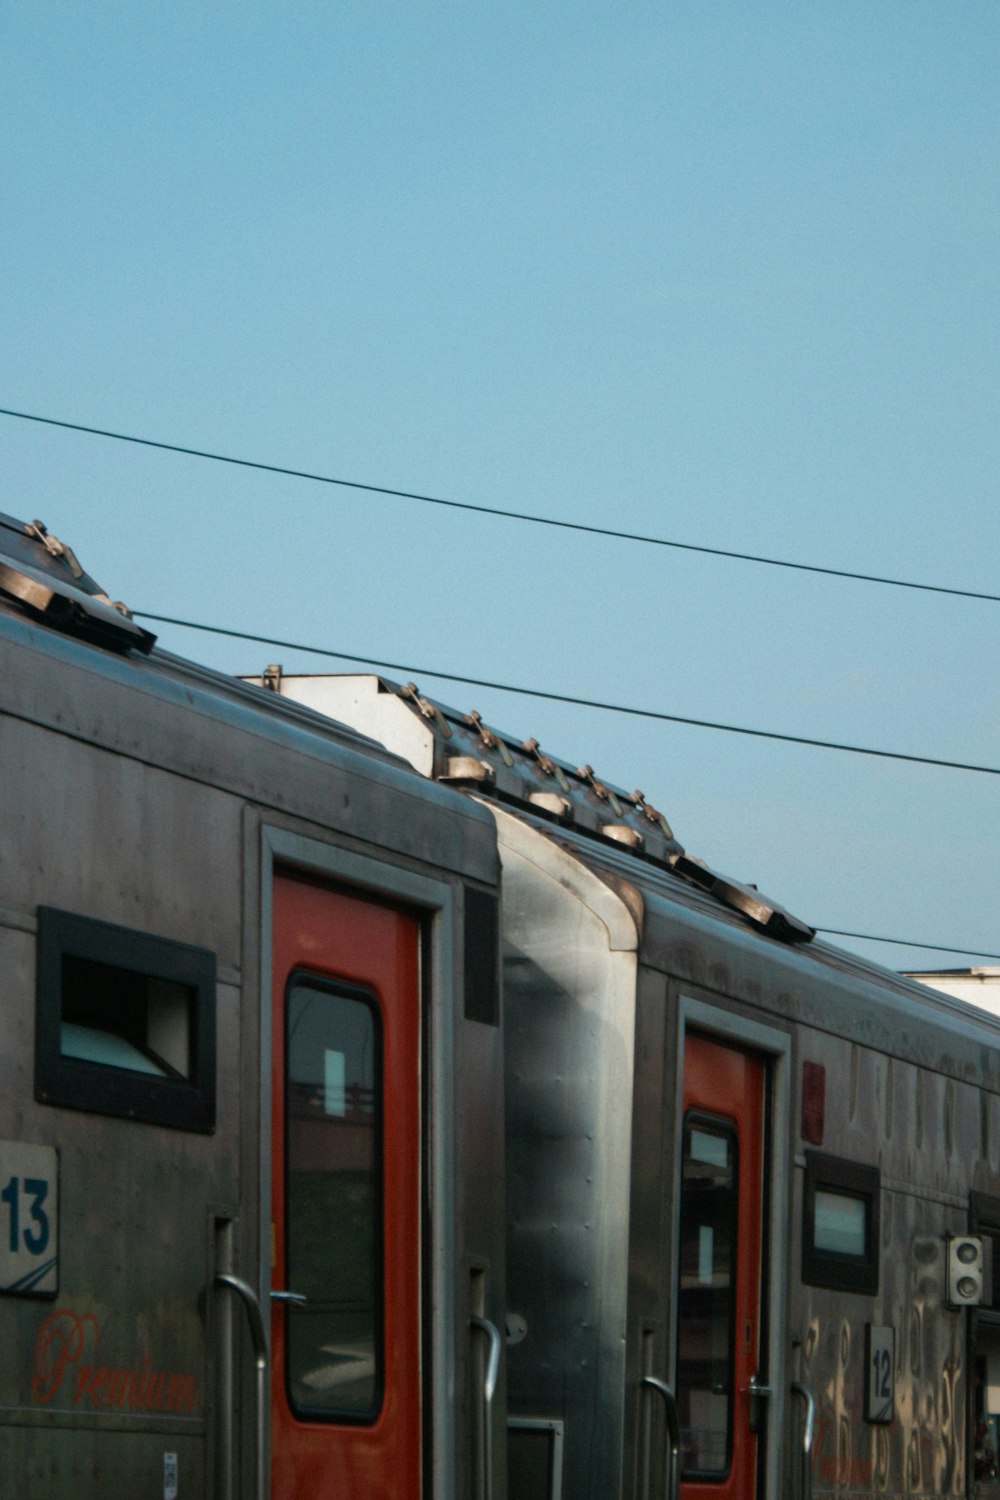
<box><xmin>0</xmin><ymin>1140</ymin><xmax>58</xmax><ymax>1298</ymax></box>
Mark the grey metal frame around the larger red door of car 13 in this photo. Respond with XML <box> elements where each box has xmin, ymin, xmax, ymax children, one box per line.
<box><xmin>255</xmin><ymin>824</ymin><xmax>460</xmax><ymax>1500</ymax></box>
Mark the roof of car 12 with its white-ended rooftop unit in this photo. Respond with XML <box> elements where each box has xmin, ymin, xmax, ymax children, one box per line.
<box><xmin>256</xmin><ymin>668</ymin><xmax>1000</xmax><ymax>1092</ymax></box>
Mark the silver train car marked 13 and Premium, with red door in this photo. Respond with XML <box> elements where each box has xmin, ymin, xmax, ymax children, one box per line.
<box><xmin>0</xmin><ymin>516</ymin><xmax>505</xmax><ymax>1500</ymax></box>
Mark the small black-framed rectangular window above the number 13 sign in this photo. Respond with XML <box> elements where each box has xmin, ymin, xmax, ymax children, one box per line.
<box><xmin>34</xmin><ymin>906</ymin><xmax>216</xmax><ymax>1133</ymax></box>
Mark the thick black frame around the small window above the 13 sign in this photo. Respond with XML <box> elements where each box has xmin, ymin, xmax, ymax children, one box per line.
<box><xmin>34</xmin><ymin>906</ymin><xmax>216</xmax><ymax>1136</ymax></box>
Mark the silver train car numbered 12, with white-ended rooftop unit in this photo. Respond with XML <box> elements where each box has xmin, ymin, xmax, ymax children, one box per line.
<box><xmin>256</xmin><ymin>666</ymin><xmax>1000</xmax><ymax>1500</ymax></box>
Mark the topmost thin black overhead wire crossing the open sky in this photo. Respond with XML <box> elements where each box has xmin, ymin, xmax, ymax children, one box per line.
<box><xmin>0</xmin><ymin>407</ymin><xmax>1000</xmax><ymax>605</ymax></box>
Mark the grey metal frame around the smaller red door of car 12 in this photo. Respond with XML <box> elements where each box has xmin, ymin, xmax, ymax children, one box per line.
<box><xmin>670</xmin><ymin>990</ymin><xmax>792</xmax><ymax>1500</ymax></box>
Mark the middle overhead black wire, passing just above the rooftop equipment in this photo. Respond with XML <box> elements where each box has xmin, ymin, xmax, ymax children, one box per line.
<box><xmin>135</xmin><ymin>609</ymin><xmax>1000</xmax><ymax>776</ymax></box>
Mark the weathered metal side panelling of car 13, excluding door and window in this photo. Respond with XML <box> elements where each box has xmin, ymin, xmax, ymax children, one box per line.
<box><xmin>0</xmin><ymin>567</ymin><xmax>504</xmax><ymax>1500</ymax></box>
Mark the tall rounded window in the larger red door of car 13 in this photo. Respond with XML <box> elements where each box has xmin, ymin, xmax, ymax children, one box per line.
<box><xmin>285</xmin><ymin>977</ymin><xmax>382</xmax><ymax>1422</ymax></box>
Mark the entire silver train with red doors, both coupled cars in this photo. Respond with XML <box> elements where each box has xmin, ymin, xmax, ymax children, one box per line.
<box><xmin>0</xmin><ymin>516</ymin><xmax>1000</xmax><ymax>1500</ymax></box>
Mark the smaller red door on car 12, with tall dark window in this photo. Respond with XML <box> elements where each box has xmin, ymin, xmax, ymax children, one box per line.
<box><xmin>676</xmin><ymin>1035</ymin><xmax>766</xmax><ymax>1500</ymax></box>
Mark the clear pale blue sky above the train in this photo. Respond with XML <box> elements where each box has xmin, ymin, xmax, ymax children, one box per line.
<box><xmin>0</xmin><ymin>0</ymin><xmax>1000</xmax><ymax>968</ymax></box>
